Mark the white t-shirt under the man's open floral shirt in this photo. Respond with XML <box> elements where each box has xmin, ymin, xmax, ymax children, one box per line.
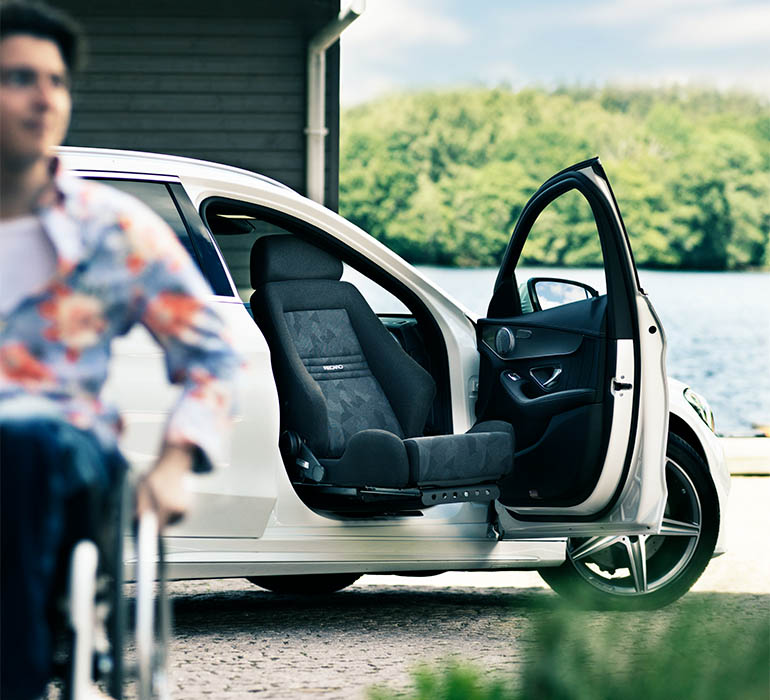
<box><xmin>0</xmin><ymin>216</ymin><xmax>56</xmax><ymax>315</ymax></box>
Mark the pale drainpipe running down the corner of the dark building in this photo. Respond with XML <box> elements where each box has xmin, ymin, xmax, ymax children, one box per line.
<box><xmin>305</xmin><ymin>0</ymin><xmax>366</xmax><ymax>204</ymax></box>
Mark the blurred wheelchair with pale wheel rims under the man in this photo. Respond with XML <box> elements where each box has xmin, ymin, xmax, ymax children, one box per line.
<box><xmin>48</xmin><ymin>477</ymin><xmax>171</xmax><ymax>700</ymax></box>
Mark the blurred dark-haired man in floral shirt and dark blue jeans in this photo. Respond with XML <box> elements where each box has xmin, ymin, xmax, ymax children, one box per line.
<box><xmin>0</xmin><ymin>2</ymin><xmax>237</xmax><ymax>700</ymax></box>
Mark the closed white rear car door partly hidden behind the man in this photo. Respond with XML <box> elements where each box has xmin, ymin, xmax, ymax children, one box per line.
<box><xmin>70</xmin><ymin>170</ymin><xmax>282</xmax><ymax>540</ymax></box>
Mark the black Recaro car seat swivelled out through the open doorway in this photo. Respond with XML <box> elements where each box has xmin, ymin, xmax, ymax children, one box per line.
<box><xmin>251</xmin><ymin>235</ymin><xmax>514</xmax><ymax>508</ymax></box>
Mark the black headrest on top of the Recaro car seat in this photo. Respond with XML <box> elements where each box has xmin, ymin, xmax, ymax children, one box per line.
<box><xmin>250</xmin><ymin>235</ymin><xmax>342</xmax><ymax>289</ymax></box>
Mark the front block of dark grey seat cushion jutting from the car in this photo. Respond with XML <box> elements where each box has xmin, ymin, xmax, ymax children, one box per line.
<box><xmin>404</xmin><ymin>424</ymin><xmax>513</xmax><ymax>486</ymax></box>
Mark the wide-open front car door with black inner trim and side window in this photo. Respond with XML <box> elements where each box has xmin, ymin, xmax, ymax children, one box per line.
<box><xmin>477</xmin><ymin>159</ymin><xmax>668</xmax><ymax>537</ymax></box>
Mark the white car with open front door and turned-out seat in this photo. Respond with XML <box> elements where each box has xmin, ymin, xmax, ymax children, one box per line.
<box><xmin>61</xmin><ymin>148</ymin><xmax>729</xmax><ymax>608</ymax></box>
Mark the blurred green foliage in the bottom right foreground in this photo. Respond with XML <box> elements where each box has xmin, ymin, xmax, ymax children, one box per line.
<box><xmin>369</xmin><ymin>601</ymin><xmax>770</xmax><ymax>700</ymax></box>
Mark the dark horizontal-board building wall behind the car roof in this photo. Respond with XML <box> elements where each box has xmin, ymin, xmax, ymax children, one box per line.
<box><xmin>53</xmin><ymin>0</ymin><xmax>339</xmax><ymax>209</ymax></box>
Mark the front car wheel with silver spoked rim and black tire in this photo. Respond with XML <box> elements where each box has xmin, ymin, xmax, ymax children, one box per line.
<box><xmin>540</xmin><ymin>433</ymin><xmax>719</xmax><ymax>610</ymax></box>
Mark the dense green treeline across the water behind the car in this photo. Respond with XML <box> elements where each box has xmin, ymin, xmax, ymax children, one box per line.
<box><xmin>340</xmin><ymin>88</ymin><xmax>770</xmax><ymax>270</ymax></box>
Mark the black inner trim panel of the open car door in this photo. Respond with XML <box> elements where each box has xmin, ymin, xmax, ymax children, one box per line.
<box><xmin>478</xmin><ymin>297</ymin><xmax>607</xmax><ymax>506</ymax></box>
